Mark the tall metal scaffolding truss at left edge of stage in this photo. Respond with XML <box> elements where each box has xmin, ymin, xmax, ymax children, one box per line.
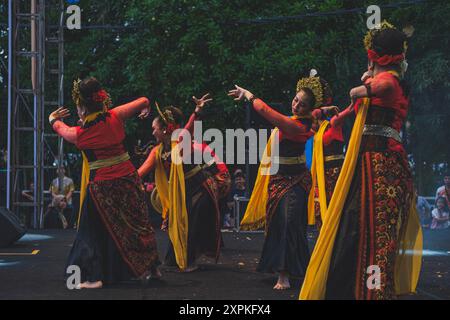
<box><xmin>7</xmin><ymin>0</ymin><xmax>64</xmax><ymax>228</ymax></box>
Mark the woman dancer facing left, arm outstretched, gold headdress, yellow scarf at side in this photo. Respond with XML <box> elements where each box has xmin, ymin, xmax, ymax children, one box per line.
<box><xmin>229</xmin><ymin>77</ymin><xmax>323</xmax><ymax>290</ymax></box>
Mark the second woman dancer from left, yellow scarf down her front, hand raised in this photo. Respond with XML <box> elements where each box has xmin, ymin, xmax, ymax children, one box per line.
<box><xmin>138</xmin><ymin>96</ymin><xmax>231</xmax><ymax>272</ymax></box>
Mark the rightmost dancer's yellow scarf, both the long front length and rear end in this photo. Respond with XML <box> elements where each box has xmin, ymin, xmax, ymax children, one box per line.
<box><xmin>299</xmin><ymin>98</ymin><xmax>422</xmax><ymax>300</ymax></box>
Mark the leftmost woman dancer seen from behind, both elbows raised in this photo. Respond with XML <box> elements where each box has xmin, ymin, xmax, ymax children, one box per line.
<box><xmin>49</xmin><ymin>78</ymin><xmax>160</xmax><ymax>288</ymax></box>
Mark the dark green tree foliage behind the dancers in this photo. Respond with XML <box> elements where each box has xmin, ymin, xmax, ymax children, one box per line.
<box><xmin>1</xmin><ymin>0</ymin><xmax>450</xmax><ymax>194</ymax></box>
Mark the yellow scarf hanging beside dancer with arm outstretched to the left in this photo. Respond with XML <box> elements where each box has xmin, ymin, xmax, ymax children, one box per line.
<box><xmin>241</xmin><ymin>128</ymin><xmax>278</xmax><ymax>230</ymax></box>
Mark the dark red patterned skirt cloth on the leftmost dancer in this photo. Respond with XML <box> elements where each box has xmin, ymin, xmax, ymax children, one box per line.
<box><xmin>89</xmin><ymin>173</ymin><xmax>158</xmax><ymax>277</ymax></box>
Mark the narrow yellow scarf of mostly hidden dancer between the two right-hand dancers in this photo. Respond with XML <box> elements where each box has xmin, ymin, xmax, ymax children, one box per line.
<box><xmin>308</xmin><ymin>120</ymin><xmax>329</xmax><ymax>225</ymax></box>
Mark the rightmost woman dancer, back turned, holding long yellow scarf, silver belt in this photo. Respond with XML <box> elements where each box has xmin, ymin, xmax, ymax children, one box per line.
<box><xmin>300</xmin><ymin>22</ymin><xmax>422</xmax><ymax>299</ymax></box>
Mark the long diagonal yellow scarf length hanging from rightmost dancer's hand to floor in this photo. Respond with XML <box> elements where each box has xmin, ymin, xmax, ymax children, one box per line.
<box><xmin>300</xmin><ymin>99</ymin><xmax>370</xmax><ymax>300</ymax></box>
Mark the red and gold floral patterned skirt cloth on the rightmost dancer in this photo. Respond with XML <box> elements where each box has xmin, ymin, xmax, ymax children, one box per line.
<box><xmin>355</xmin><ymin>151</ymin><xmax>413</xmax><ymax>300</ymax></box>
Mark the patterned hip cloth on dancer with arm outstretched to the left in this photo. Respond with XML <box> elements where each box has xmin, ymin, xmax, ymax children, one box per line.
<box><xmin>266</xmin><ymin>167</ymin><xmax>312</xmax><ymax>231</ymax></box>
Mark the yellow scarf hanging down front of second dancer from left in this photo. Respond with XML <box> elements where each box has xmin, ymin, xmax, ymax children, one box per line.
<box><xmin>155</xmin><ymin>141</ymin><xmax>188</xmax><ymax>270</ymax></box>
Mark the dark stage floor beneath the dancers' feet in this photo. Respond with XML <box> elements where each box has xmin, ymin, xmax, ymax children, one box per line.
<box><xmin>0</xmin><ymin>230</ymin><xmax>450</xmax><ymax>300</ymax></box>
